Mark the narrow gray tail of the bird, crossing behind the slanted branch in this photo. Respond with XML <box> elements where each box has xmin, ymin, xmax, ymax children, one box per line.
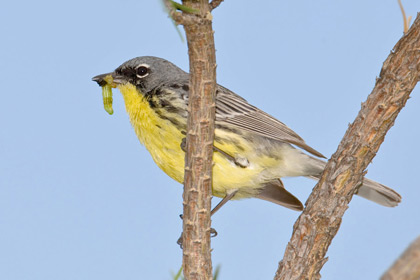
<box><xmin>307</xmin><ymin>158</ymin><xmax>401</xmax><ymax>207</ymax></box>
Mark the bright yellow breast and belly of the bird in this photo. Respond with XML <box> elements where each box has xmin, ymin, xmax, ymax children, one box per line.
<box><xmin>118</xmin><ymin>84</ymin><xmax>262</xmax><ymax>199</ymax></box>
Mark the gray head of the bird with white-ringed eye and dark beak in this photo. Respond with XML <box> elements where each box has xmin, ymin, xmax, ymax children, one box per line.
<box><xmin>92</xmin><ymin>56</ymin><xmax>188</xmax><ymax>94</ymax></box>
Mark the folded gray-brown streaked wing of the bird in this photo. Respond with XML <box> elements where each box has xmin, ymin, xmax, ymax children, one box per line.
<box><xmin>216</xmin><ymin>86</ymin><xmax>325</xmax><ymax>158</ymax></box>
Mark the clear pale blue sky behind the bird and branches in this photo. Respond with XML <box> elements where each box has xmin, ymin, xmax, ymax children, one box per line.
<box><xmin>0</xmin><ymin>0</ymin><xmax>420</xmax><ymax>280</ymax></box>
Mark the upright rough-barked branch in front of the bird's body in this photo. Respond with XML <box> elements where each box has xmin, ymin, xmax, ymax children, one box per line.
<box><xmin>178</xmin><ymin>0</ymin><xmax>216</xmax><ymax>280</ymax></box>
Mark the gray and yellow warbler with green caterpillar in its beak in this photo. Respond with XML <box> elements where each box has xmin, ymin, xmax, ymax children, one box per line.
<box><xmin>93</xmin><ymin>56</ymin><xmax>401</xmax><ymax>213</ymax></box>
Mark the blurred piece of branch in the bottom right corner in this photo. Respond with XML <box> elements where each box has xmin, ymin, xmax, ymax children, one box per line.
<box><xmin>381</xmin><ymin>236</ymin><xmax>420</xmax><ymax>280</ymax></box>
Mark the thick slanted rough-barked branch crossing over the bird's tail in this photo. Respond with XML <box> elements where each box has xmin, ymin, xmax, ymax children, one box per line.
<box><xmin>275</xmin><ymin>16</ymin><xmax>420</xmax><ymax>279</ymax></box>
